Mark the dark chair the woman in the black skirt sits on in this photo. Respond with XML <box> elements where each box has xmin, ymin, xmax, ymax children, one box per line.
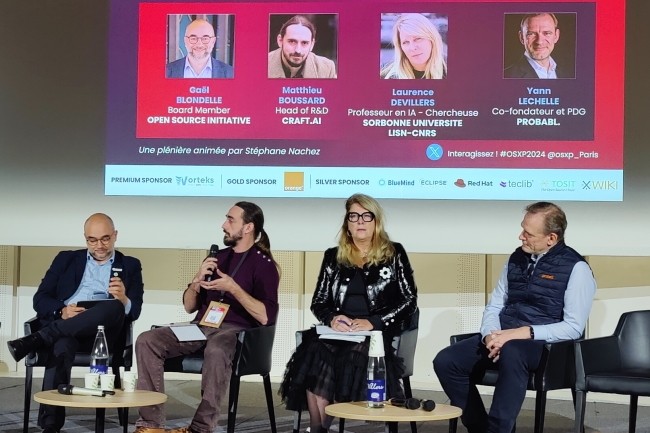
<box><xmin>293</xmin><ymin>309</ymin><xmax>420</xmax><ymax>433</ymax></box>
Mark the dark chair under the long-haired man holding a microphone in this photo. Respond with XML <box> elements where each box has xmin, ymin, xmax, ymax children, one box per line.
<box><xmin>160</xmin><ymin>325</ymin><xmax>277</xmax><ymax>433</ymax></box>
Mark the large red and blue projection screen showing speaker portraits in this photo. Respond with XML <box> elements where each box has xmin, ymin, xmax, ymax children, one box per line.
<box><xmin>105</xmin><ymin>0</ymin><xmax>625</xmax><ymax>201</ymax></box>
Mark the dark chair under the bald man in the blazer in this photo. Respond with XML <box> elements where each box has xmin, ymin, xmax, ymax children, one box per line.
<box><xmin>23</xmin><ymin>317</ymin><xmax>133</xmax><ymax>433</ymax></box>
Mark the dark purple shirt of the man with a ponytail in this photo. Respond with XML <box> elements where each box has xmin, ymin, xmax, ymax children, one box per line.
<box><xmin>194</xmin><ymin>246</ymin><xmax>280</xmax><ymax>328</ymax></box>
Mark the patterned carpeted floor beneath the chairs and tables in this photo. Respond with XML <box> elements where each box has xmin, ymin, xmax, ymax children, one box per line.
<box><xmin>0</xmin><ymin>377</ymin><xmax>650</xmax><ymax>433</ymax></box>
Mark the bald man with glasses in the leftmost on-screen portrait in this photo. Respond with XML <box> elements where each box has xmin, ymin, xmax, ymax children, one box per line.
<box><xmin>165</xmin><ymin>18</ymin><xmax>234</xmax><ymax>78</ymax></box>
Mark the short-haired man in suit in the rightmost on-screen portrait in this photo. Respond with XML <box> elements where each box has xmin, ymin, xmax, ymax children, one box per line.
<box><xmin>503</xmin><ymin>12</ymin><xmax>575</xmax><ymax>79</ymax></box>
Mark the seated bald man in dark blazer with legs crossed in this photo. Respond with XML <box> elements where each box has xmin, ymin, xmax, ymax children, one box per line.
<box><xmin>7</xmin><ymin>213</ymin><xmax>144</xmax><ymax>433</ymax></box>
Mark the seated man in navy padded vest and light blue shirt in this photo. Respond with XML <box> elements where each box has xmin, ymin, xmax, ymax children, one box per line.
<box><xmin>433</xmin><ymin>202</ymin><xmax>596</xmax><ymax>433</ymax></box>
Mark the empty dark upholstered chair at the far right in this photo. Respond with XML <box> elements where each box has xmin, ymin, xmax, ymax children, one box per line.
<box><xmin>575</xmin><ymin>310</ymin><xmax>650</xmax><ymax>433</ymax></box>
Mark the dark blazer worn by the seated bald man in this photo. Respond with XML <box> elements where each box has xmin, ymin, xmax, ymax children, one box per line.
<box><xmin>34</xmin><ymin>249</ymin><xmax>144</xmax><ymax>322</ymax></box>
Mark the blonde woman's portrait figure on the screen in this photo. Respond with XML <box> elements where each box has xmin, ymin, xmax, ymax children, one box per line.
<box><xmin>381</xmin><ymin>13</ymin><xmax>447</xmax><ymax>79</ymax></box>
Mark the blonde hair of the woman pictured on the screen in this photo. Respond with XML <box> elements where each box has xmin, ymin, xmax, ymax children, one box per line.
<box><xmin>381</xmin><ymin>14</ymin><xmax>447</xmax><ymax>79</ymax></box>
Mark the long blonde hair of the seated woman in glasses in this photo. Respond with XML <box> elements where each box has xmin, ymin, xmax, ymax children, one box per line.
<box><xmin>336</xmin><ymin>194</ymin><xmax>395</xmax><ymax>266</ymax></box>
